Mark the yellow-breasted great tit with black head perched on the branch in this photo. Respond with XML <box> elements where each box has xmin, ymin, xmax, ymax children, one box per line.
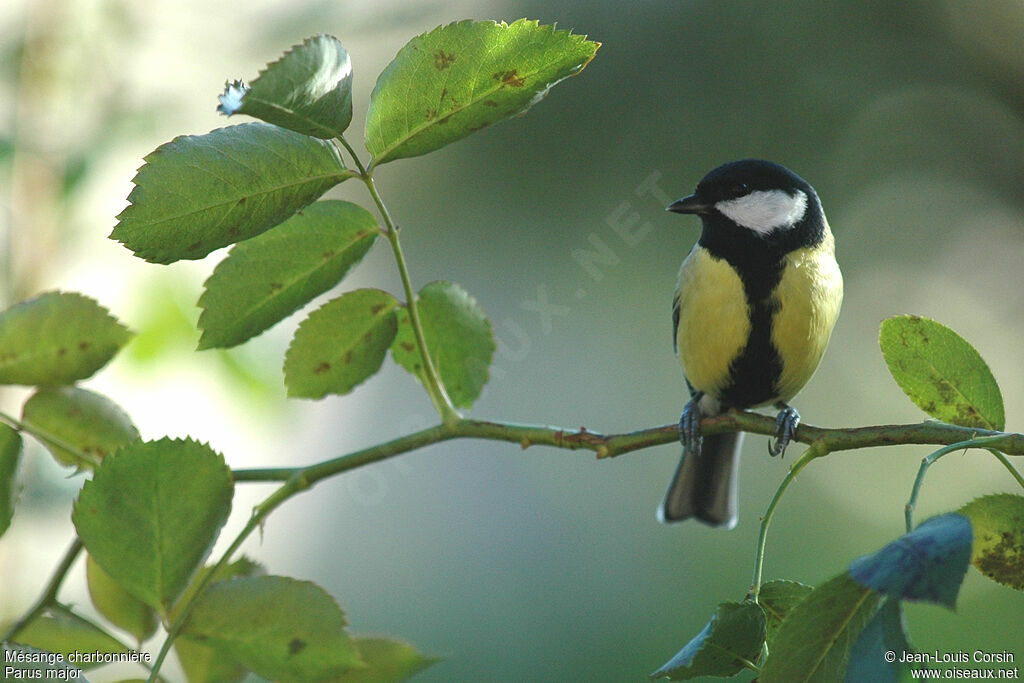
<box><xmin>658</xmin><ymin>159</ymin><xmax>843</xmax><ymax>528</ymax></box>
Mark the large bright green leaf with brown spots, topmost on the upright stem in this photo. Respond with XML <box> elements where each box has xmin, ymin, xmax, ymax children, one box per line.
<box><xmin>367</xmin><ymin>19</ymin><xmax>600</xmax><ymax>166</ymax></box>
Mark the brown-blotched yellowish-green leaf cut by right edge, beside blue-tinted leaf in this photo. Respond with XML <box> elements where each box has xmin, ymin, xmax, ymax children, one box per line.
<box><xmin>959</xmin><ymin>494</ymin><xmax>1024</xmax><ymax>591</ymax></box>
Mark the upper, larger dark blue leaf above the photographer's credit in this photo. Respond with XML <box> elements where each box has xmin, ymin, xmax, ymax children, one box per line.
<box><xmin>850</xmin><ymin>513</ymin><xmax>972</xmax><ymax>609</ymax></box>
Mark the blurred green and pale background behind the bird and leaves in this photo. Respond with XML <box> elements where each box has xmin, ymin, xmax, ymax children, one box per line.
<box><xmin>0</xmin><ymin>0</ymin><xmax>1024</xmax><ymax>681</ymax></box>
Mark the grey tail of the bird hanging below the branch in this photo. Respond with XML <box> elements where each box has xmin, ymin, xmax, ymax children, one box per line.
<box><xmin>657</xmin><ymin>432</ymin><xmax>743</xmax><ymax>528</ymax></box>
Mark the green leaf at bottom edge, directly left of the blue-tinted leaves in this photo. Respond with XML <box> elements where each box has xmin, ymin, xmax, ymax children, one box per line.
<box><xmin>758</xmin><ymin>573</ymin><xmax>882</xmax><ymax>683</ymax></box>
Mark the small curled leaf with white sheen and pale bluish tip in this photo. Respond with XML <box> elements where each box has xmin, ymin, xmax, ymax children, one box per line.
<box><xmin>217</xmin><ymin>34</ymin><xmax>352</xmax><ymax>138</ymax></box>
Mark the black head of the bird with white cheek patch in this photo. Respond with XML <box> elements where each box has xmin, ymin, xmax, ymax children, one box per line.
<box><xmin>668</xmin><ymin>159</ymin><xmax>825</xmax><ymax>252</ymax></box>
